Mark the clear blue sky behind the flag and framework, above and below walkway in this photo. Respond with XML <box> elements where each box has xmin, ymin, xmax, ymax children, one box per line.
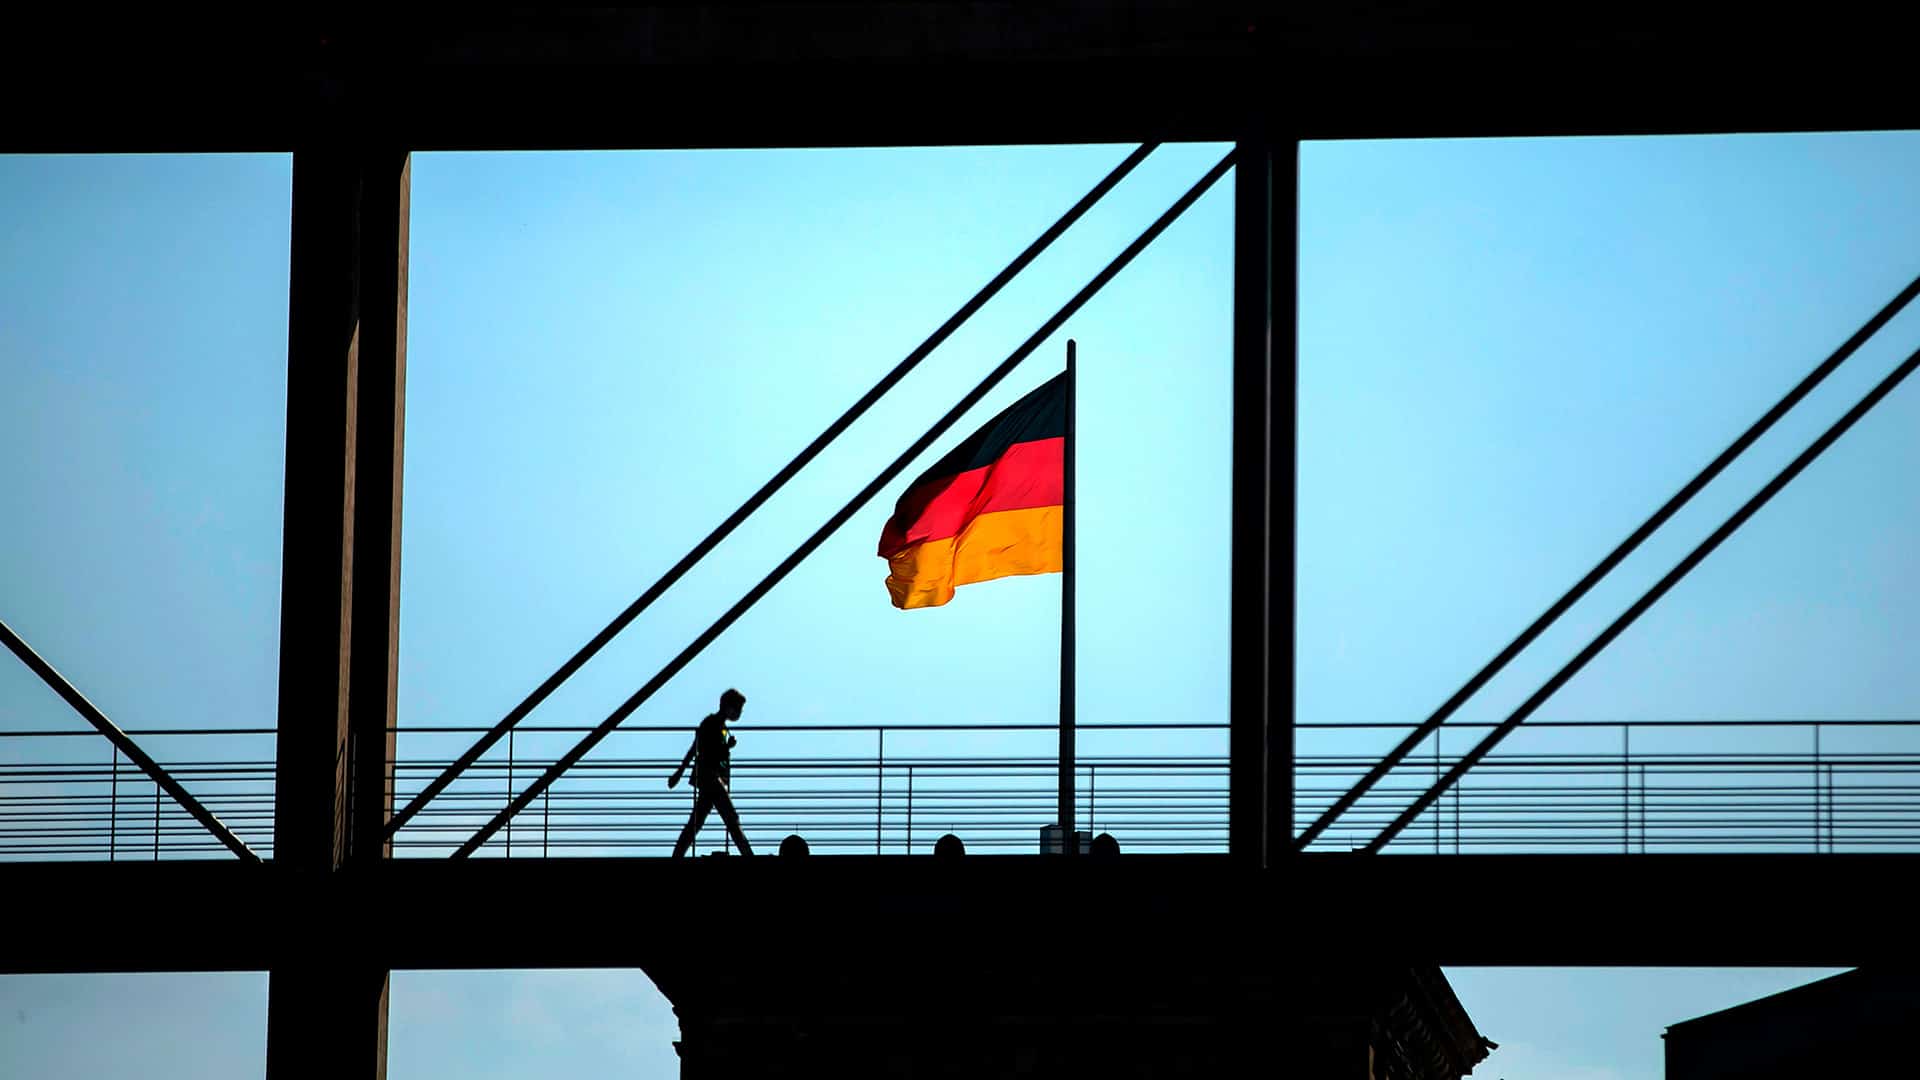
<box><xmin>0</xmin><ymin>135</ymin><xmax>1920</xmax><ymax>1080</ymax></box>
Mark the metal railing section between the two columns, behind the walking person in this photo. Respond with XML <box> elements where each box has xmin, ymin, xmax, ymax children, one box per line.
<box><xmin>394</xmin><ymin>724</ymin><xmax>1227</xmax><ymax>859</ymax></box>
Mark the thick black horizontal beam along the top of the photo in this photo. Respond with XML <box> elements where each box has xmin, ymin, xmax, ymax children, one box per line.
<box><xmin>0</xmin><ymin>0</ymin><xmax>1920</xmax><ymax>152</ymax></box>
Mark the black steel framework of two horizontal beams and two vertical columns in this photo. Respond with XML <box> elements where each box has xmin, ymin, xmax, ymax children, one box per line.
<box><xmin>0</xmin><ymin>8</ymin><xmax>1920</xmax><ymax>1076</ymax></box>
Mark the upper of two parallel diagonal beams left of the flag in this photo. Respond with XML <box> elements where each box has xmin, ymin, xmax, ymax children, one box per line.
<box><xmin>386</xmin><ymin>142</ymin><xmax>1160</xmax><ymax>840</ymax></box>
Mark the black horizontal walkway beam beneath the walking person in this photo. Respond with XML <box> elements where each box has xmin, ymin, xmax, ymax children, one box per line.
<box><xmin>0</xmin><ymin>853</ymin><xmax>1920</xmax><ymax>972</ymax></box>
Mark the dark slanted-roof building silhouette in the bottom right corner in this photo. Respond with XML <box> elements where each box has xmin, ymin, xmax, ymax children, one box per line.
<box><xmin>1665</xmin><ymin>967</ymin><xmax>1920</xmax><ymax>1080</ymax></box>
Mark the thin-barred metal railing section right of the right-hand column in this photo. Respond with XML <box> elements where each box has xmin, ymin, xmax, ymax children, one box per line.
<box><xmin>1294</xmin><ymin>721</ymin><xmax>1920</xmax><ymax>853</ymax></box>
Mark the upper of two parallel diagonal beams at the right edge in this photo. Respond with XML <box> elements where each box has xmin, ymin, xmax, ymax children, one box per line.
<box><xmin>1294</xmin><ymin>277</ymin><xmax>1920</xmax><ymax>851</ymax></box>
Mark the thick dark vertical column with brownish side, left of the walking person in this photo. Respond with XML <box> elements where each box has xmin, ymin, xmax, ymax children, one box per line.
<box><xmin>267</xmin><ymin>140</ymin><xmax>411</xmax><ymax>1080</ymax></box>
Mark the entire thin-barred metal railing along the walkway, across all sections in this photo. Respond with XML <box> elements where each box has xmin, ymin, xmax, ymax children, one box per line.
<box><xmin>0</xmin><ymin>721</ymin><xmax>1920</xmax><ymax>861</ymax></box>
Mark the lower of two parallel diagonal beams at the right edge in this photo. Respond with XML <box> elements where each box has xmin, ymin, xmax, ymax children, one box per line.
<box><xmin>1363</xmin><ymin>338</ymin><xmax>1920</xmax><ymax>855</ymax></box>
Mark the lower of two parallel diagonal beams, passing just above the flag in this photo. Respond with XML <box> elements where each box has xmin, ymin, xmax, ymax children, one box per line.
<box><xmin>453</xmin><ymin>152</ymin><xmax>1235</xmax><ymax>859</ymax></box>
